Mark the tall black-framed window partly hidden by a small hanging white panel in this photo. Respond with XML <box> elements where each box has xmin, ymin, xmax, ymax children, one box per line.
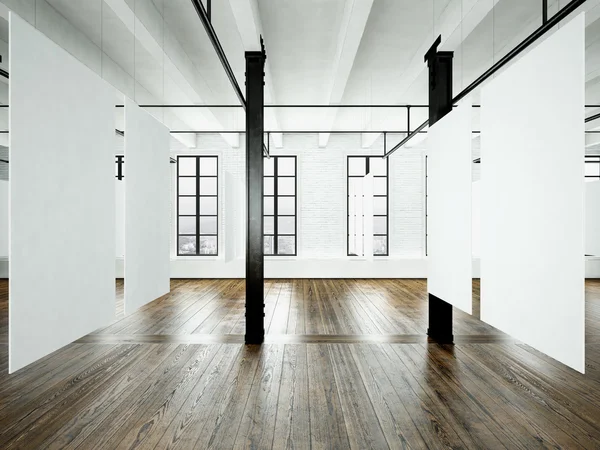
<box><xmin>346</xmin><ymin>156</ymin><xmax>389</xmax><ymax>256</ymax></box>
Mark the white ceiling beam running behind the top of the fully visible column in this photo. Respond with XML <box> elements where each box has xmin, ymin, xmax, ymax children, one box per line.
<box><xmin>229</xmin><ymin>0</ymin><xmax>283</xmax><ymax>137</ymax></box>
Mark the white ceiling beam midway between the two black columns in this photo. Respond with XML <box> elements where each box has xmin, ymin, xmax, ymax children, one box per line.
<box><xmin>319</xmin><ymin>0</ymin><xmax>373</xmax><ymax>147</ymax></box>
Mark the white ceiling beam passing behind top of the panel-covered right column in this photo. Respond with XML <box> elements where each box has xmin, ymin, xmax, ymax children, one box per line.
<box><xmin>363</xmin><ymin>0</ymin><xmax>499</xmax><ymax>148</ymax></box>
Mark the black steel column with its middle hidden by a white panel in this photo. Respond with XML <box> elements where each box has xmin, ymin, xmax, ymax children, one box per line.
<box><xmin>425</xmin><ymin>37</ymin><xmax>454</xmax><ymax>344</ymax></box>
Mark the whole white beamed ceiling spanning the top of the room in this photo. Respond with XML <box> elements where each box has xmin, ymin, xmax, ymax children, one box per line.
<box><xmin>0</xmin><ymin>0</ymin><xmax>600</xmax><ymax>148</ymax></box>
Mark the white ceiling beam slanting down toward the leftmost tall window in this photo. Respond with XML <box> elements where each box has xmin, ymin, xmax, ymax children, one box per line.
<box><xmin>104</xmin><ymin>0</ymin><xmax>239</xmax><ymax>147</ymax></box>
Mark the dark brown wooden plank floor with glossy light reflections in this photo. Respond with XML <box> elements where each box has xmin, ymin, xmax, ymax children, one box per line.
<box><xmin>0</xmin><ymin>280</ymin><xmax>600</xmax><ymax>450</ymax></box>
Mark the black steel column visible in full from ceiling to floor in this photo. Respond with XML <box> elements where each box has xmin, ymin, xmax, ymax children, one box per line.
<box><xmin>245</xmin><ymin>50</ymin><xmax>266</xmax><ymax>344</ymax></box>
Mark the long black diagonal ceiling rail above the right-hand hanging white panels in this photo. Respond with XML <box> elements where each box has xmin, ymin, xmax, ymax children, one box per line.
<box><xmin>383</xmin><ymin>0</ymin><xmax>586</xmax><ymax>158</ymax></box>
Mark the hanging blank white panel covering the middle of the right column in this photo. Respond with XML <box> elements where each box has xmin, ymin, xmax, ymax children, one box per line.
<box><xmin>427</xmin><ymin>102</ymin><xmax>473</xmax><ymax>314</ymax></box>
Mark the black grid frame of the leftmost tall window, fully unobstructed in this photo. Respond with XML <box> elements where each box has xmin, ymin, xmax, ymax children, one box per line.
<box><xmin>175</xmin><ymin>155</ymin><xmax>220</xmax><ymax>257</ymax></box>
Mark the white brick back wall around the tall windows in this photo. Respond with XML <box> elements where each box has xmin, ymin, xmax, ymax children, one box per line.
<box><xmin>171</xmin><ymin>134</ymin><xmax>426</xmax><ymax>278</ymax></box>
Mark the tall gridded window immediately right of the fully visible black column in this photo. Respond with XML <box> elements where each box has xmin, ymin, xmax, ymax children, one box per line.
<box><xmin>263</xmin><ymin>156</ymin><xmax>297</xmax><ymax>256</ymax></box>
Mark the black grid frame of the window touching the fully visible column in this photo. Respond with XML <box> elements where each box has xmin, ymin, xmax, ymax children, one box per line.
<box><xmin>263</xmin><ymin>155</ymin><xmax>298</xmax><ymax>257</ymax></box>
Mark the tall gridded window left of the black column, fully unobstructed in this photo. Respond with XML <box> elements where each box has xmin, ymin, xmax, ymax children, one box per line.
<box><xmin>177</xmin><ymin>156</ymin><xmax>219</xmax><ymax>256</ymax></box>
